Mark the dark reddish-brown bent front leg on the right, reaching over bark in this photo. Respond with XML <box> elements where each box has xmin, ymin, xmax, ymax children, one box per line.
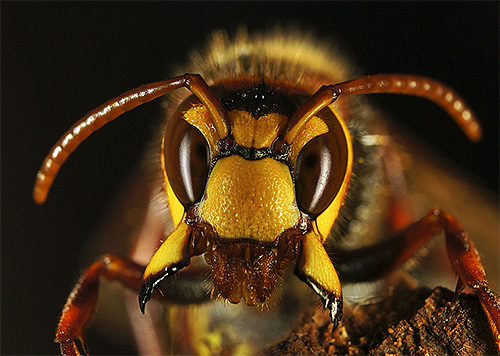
<box><xmin>334</xmin><ymin>209</ymin><xmax>500</xmax><ymax>349</ymax></box>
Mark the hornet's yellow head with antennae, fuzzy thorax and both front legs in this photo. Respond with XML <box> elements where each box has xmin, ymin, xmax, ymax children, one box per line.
<box><xmin>34</xmin><ymin>32</ymin><xmax>500</xmax><ymax>354</ymax></box>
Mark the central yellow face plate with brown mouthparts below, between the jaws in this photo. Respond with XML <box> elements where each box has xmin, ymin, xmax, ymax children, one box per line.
<box><xmin>198</xmin><ymin>156</ymin><xmax>300</xmax><ymax>305</ymax></box>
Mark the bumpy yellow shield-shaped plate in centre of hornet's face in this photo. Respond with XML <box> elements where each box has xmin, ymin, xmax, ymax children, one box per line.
<box><xmin>198</xmin><ymin>156</ymin><xmax>299</xmax><ymax>241</ymax></box>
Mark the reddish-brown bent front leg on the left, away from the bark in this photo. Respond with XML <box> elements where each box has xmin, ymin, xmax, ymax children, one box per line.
<box><xmin>56</xmin><ymin>255</ymin><xmax>145</xmax><ymax>355</ymax></box>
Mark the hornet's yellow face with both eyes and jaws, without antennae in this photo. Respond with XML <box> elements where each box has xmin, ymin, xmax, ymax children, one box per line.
<box><xmin>140</xmin><ymin>83</ymin><xmax>351</xmax><ymax>318</ymax></box>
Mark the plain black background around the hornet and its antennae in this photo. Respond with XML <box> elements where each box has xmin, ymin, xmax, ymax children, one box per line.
<box><xmin>1</xmin><ymin>2</ymin><xmax>499</xmax><ymax>354</ymax></box>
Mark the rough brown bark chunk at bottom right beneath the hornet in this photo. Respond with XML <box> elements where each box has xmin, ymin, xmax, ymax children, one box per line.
<box><xmin>264</xmin><ymin>283</ymin><xmax>497</xmax><ymax>356</ymax></box>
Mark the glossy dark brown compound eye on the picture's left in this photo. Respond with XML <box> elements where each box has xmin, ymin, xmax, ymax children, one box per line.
<box><xmin>164</xmin><ymin>120</ymin><xmax>210</xmax><ymax>207</ymax></box>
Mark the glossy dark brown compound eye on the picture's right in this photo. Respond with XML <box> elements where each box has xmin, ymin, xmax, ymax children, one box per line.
<box><xmin>295</xmin><ymin>132</ymin><xmax>347</xmax><ymax>219</ymax></box>
